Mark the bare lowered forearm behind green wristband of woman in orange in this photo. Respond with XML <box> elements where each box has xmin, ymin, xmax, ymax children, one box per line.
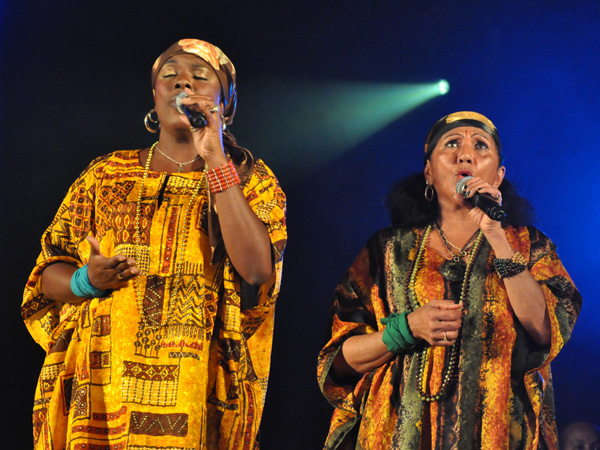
<box><xmin>333</xmin><ymin>331</ymin><xmax>393</xmax><ymax>378</ymax></box>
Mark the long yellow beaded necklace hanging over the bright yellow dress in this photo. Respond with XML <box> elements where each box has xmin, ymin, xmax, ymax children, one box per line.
<box><xmin>133</xmin><ymin>142</ymin><xmax>206</xmax><ymax>331</ymax></box>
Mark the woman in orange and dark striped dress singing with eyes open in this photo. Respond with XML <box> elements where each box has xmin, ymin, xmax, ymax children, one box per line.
<box><xmin>319</xmin><ymin>111</ymin><xmax>581</xmax><ymax>450</ymax></box>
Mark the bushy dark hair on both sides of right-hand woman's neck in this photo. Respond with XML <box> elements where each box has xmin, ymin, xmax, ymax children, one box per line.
<box><xmin>384</xmin><ymin>173</ymin><xmax>535</xmax><ymax>228</ymax></box>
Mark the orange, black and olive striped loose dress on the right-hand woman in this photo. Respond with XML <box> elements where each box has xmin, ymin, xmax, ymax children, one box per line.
<box><xmin>318</xmin><ymin>227</ymin><xmax>581</xmax><ymax>450</ymax></box>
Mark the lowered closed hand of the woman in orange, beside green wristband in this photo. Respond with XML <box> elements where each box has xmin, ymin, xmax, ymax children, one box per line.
<box><xmin>406</xmin><ymin>300</ymin><xmax>463</xmax><ymax>347</ymax></box>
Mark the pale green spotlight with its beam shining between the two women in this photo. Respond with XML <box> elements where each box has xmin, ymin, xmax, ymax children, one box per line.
<box><xmin>233</xmin><ymin>80</ymin><xmax>449</xmax><ymax>173</ymax></box>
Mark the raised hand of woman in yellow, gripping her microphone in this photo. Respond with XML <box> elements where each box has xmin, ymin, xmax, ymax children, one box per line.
<box><xmin>181</xmin><ymin>88</ymin><xmax>227</xmax><ymax>167</ymax></box>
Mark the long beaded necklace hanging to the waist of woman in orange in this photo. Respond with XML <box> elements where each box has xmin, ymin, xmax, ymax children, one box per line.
<box><xmin>406</xmin><ymin>225</ymin><xmax>483</xmax><ymax>403</ymax></box>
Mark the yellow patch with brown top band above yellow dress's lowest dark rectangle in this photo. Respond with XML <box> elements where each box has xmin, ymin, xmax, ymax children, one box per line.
<box><xmin>121</xmin><ymin>361</ymin><xmax>179</xmax><ymax>406</ymax></box>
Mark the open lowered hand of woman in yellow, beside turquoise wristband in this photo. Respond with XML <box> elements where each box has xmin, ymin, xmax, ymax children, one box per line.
<box><xmin>87</xmin><ymin>236</ymin><xmax>140</xmax><ymax>291</ymax></box>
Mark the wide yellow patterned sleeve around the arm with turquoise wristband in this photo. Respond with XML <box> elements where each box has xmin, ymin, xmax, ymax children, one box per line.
<box><xmin>21</xmin><ymin>157</ymin><xmax>104</xmax><ymax>351</ymax></box>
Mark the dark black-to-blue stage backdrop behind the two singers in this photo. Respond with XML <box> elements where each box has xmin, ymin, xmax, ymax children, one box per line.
<box><xmin>0</xmin><ymin>0</ymin><xmax>600</xmax><ymax>450</ymax></box>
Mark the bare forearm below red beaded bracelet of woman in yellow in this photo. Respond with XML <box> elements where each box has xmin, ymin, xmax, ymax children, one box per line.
<box><xmin>215</xmin><ymin>185</ymin><xmax>273</xmax><ymax>285</ymax></box>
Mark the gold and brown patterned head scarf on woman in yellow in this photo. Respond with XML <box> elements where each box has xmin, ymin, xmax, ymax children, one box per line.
<box><xmin>152</xmin><ymin>39</ymin><xmax>237</xmax><ymax>125</ymax></box>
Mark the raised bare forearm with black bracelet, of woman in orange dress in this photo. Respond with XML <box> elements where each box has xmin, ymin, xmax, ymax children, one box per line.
<box><xmin>488</xmin><ymin>231</ymin><xmax>552</xmax><ymax>345</ymax></box>
